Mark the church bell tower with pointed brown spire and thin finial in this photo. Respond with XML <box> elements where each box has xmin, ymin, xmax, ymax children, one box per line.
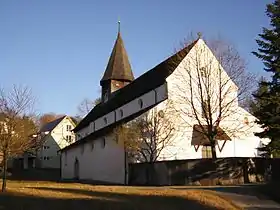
<box><xmin>100</xmin><ymin>21</ymin><xmax>134</xmax><ymax>102</ymax></box>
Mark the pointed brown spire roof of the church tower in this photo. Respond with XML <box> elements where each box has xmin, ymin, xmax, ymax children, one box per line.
<box><xmin>100</xmin><ymin>32</ymin><xmax>134</xmax><ymax>83</ymax></box>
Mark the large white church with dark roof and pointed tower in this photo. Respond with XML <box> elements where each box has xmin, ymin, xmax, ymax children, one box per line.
<box><xmin>61</xmin><ymin>25</ymin><xmax>267</xmax><ymax>184</ymax></box>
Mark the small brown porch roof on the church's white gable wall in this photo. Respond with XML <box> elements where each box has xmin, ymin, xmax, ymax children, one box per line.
<box><xmin>191</xmin><ymin>125</ymin><xmax>231</xmax><ymax>145</ymax></box>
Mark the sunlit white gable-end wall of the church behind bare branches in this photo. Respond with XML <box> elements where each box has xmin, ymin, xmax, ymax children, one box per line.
<box><xmin>154</xmin><ymin>40</ymin><xmax>268</xmax><ymax>160</ymax></box>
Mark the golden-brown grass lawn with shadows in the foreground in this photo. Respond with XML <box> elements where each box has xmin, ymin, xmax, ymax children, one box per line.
<box><xmin>0</xmin><ymin>181</ymin><xmax>241</xmax><ymax>210</ymax></box>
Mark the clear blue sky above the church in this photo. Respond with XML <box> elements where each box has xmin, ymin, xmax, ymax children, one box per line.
<box><xmin>0</xmin><ymin>0</ymin><xmax>272</xmax><ymax>115</ymax></box>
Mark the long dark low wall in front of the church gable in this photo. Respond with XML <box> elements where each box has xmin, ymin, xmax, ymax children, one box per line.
<box><xmin>129</xmin><ymin>158</ymin><xmax>280</xmax><ymax>185</ymax></box>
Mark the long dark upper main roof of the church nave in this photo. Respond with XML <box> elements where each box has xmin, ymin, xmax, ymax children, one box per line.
<box><xmin>74</xmin><ymin>40</ymin><xmax>198</xmax><ymax>132</ymax></box>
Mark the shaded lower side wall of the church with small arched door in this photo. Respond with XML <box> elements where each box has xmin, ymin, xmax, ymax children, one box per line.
<box><xmin>61</xmin><ymin>136</ymin><xmax>125</xmax><ymax>184</ymax></box>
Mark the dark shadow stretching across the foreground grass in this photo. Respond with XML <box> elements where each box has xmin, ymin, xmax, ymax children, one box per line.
<box><xmin>0</xmin><ymin>187</ymin><xmax>215</xmax><ymax>210</ymax></box>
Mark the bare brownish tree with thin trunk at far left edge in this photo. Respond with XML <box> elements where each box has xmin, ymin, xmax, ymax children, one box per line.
<box><xmin>0</xmin><ymin>86</ymin><xmax>37</xmax><ymax>191</ymax></box>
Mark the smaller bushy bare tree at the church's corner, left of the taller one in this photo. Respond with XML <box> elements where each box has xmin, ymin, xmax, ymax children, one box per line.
<box><xmin>115</xmin><ymin>100</ymin><xmax>178</xmax><ymax>163</ymax></box>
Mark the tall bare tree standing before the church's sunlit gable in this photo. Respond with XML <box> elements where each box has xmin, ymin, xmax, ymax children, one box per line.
<box><xmin>171</xmin><ymin>36</ymin><xmax>253</xmax><ymax>159</ymax></box>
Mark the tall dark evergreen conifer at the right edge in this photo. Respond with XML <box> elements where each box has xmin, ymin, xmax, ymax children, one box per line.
<box><xmin>253</xmin><ymin>0</ymin><xmax>280</xmax><ymax>157</ymax></box>
